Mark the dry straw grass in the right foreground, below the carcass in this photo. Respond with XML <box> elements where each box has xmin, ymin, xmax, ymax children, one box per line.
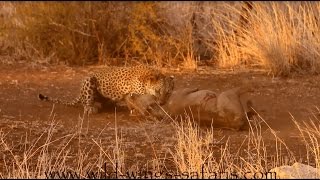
<box><xmin>172</xmin><ymin>109</ymin><xmax>320</xmax><ymax>178</ymax></box>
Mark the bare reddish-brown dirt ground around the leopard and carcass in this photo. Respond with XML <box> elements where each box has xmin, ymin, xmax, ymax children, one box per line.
<box><xmin>0</xmin><ymin>64</ymin><xmax>320</xmax><ymax>172</ymax></box>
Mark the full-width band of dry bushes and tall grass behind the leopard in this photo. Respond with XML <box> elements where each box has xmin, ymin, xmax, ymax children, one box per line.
<box><xmin>0</xmin><ymin>2</ymin><xmax>320</xmax><ymax>76</ymax></box>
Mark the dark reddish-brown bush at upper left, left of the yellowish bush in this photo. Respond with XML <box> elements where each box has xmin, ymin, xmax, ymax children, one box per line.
<box><xmin>0</xmin><ymin>2</ymin><xmax>131</xmax><ymax>64</ymax></box>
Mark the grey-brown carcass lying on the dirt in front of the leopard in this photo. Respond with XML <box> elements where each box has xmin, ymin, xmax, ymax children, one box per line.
<box><xmin>125</xmin><ymin>87</ymin><xmax>252</xmax><ymax>130</ymax></box>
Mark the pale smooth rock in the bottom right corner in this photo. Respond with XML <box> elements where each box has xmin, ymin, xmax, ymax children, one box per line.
<box><xmin>269</xmin><ymin>163</ymin><xmax>320</xmax><ymax>179</ymax></box>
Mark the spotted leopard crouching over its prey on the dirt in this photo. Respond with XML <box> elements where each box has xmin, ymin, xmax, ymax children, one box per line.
<box><xmin>38</xmin><ymin>65</ymin><xmax>174</xmax><ymax>114</ymax></box>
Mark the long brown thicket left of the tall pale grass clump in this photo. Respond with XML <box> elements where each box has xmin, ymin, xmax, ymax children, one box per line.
<box><xmin>3</xmin><ymin>2</ymin><xmax>204</xmax><ymax>68</ymax></box>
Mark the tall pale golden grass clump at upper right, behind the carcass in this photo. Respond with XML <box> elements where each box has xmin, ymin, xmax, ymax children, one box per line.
<box><xmin>206</xmin><ymin>2</ymin><xmax>320</xmax><ymax>75</ymax></box>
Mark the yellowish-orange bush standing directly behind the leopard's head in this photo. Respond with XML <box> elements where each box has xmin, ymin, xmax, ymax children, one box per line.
<box><xmin>123</xmin><ymin>2</ymin><xmax>170</xmax><ymax>67</ymax></box>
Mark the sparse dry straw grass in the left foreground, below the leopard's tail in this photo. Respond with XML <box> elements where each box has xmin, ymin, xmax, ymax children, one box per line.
<box><xmin>0</xmin><ymin>108</ymin><xmax>125</xmax><ymax>179</ymax></box>
